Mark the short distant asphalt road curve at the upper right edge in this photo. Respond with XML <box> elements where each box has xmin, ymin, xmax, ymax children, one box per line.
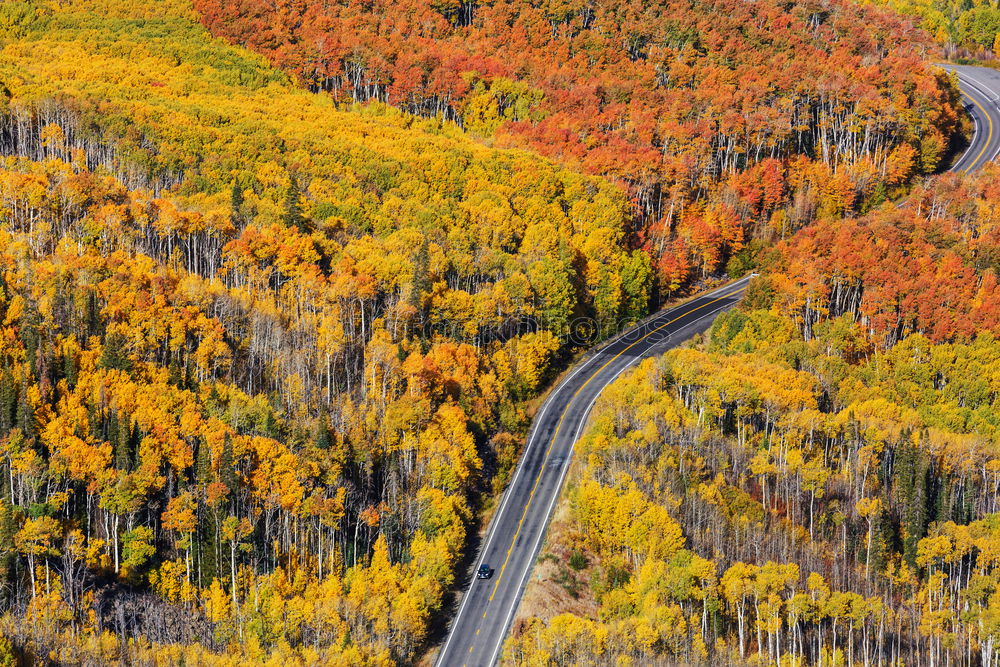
<box><xmin>939</xmin><ymin>65</ymin><xmax>1000</xmax><ymax>173</ymax></box>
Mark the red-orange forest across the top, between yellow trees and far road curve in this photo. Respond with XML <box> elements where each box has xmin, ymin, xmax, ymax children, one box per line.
<box><xmin>195</xmin><ymin>0</ymin><xmax>959</xmax><ymax>294</ymax></box>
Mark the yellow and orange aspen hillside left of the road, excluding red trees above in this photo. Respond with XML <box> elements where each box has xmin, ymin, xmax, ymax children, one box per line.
<box><xmin>0</xmin><ymin>1</ymin><xmax>650</xmax><ymax>664</ymax></box>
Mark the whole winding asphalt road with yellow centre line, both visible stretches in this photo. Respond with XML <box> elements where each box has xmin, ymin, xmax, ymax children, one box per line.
<box><xmin>436</xmin><ymin>65</ymin><xmax>1000</xmax><ymax>667</ymax></box>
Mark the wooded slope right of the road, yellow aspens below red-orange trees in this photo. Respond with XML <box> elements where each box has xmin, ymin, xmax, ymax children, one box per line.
<box><xmin>504</xmin><ymin>165</ymin><xmax>1000</xmax><ymax>665</ymax></box>
